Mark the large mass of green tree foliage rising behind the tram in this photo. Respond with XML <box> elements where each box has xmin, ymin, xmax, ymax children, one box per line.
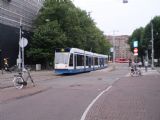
<box><xmin>27</xmin><ymin>0</ymin><xmax>110</xmax><ymax>62</ymax></box>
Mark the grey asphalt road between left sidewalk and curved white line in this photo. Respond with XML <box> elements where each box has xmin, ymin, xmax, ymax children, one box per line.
<box><xmin>0</xmin><ymin>64</ymin><xmax>132</xmax><ymax>120</ymax></box>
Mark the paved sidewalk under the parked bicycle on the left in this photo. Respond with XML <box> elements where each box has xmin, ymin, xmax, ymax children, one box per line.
<box><xmin>0</xmin><ymin>71</ymin><xmax>59</xmax><ymax>103</ymax></box>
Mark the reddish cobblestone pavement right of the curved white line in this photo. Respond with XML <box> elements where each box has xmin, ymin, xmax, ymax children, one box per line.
<box><xmin>85</xmin><ymin>69</ymin><xmax>160</xmax><ymax>120</ymax></box>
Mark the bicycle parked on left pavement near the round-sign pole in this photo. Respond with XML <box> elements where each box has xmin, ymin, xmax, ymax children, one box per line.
<box><xmin>13</xmin><ymin>69</ymin><xmax>35</xmax><ymax>89</ymax></box>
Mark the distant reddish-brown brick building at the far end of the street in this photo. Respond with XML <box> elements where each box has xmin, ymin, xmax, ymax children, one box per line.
<box><xmin>107</xmin><ymin>35</ymin><xmax>133</xmax><ymax>59</ymax></box>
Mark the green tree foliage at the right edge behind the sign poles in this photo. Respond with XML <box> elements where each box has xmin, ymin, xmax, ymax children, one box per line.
<box><xmin>129</xmin><ymin>16</ymin><xmax>160</xmax><ymax>59</ymax></box>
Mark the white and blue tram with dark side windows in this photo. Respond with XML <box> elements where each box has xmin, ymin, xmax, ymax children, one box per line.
<box><xmin>54</xmin><ymin>48</ymin><xmax>108</xmax><ymax>74</ymax></box>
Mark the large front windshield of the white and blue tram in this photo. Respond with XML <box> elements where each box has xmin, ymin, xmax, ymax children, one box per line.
<box><xmin>55</xmin><ymin>52</ymin><xmax>69</xmax><ymax>64</ymax></box>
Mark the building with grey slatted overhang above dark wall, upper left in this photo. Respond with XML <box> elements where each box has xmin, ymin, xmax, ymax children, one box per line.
<box><xmin>0</xmin><ymin>0</ymin><xmax>44</xmax><ymax>67</ymax></box>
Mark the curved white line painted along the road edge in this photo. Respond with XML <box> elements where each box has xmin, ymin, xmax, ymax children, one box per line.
<box><xmin>80</xmin><ymin>86</ymin><xmax>112</xmax><ymax>120</ymax></box>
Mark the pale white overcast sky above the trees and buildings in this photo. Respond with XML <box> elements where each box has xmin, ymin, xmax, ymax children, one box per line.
<box><xmin>72</xmin><ymin>0</ymin><xmax>160</xmax><ymax>35</ymax></box>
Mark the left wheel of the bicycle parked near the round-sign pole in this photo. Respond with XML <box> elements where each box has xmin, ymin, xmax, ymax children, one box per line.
<box><xmin>13</xmin><ymin>77</ymin><xmax>23</xmax><ymax>89</ymax></box>
